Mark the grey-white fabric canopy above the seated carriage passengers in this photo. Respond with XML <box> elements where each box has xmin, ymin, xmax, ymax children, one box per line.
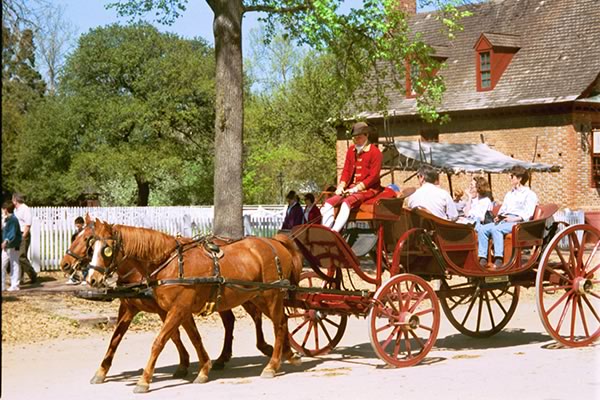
<box><xmin>394</xmin><ymin>141</ymin><xmax>560</xmax><ymax>174</ymax></box>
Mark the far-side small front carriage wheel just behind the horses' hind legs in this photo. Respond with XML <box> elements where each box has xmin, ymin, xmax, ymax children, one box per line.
<box><xmin>286</xmin><ymin>271</ymin><xmax>348</xmax><ymax>357</ymax></box>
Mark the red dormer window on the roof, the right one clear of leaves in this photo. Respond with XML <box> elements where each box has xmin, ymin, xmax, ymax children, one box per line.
<box><xmin>475</xmin><ymin>33</ymin><xmax>521</xmax><ymax>92</ymax></box>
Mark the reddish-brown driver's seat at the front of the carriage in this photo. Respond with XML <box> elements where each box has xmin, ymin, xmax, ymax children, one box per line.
<box><xmin>348</xmin><ymin>187</ymin><xmax>416</xmax><ymax>221</ymax></box>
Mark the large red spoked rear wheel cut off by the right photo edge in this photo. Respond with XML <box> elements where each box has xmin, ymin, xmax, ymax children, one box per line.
<box><xmin>535</xmin><ymin>225</ymin><xmax>600</xmax><ymax>347</ymax></box>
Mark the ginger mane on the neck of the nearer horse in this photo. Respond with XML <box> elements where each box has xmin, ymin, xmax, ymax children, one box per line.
<box><xmin>113</xmin><ymin>225</ymin><xmax>177</xmax><ymax>264</ymax></box>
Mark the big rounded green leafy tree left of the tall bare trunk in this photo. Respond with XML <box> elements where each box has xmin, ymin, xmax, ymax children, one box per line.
<box><xmin>27</xmin><ymin>24</ymin><xmax>214</xmax><ymax>206</ymax></box>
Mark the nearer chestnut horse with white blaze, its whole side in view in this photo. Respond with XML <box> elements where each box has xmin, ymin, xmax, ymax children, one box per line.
<box><xmin>86</xmin><ymin>220</ymin><xmax>302</xmax><ymax>393</ymax></box>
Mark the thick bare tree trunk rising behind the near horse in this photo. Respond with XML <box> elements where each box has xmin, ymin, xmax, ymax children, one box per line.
<box><xmin>209</xmin><ymin>0</ymin><xmax>244</xmax><ymax>238</ymax></box>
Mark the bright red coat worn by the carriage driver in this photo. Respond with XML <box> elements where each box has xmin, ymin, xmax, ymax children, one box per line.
<box><xmin>340</xmin><ymin>143</ymin><xmax>383</xmax><ymax>192</ymax></box>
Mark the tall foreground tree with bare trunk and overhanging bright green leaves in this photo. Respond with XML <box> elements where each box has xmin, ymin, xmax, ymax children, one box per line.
<box><xmin>109</xmin><ymin>0</ymin><xmax>468</xmax><ymax>237</ymax></box>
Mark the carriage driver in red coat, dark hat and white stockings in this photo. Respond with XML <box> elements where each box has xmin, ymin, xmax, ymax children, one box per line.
<box><xmin>321</xmin><ymin>122</ymin><xmax>383</xmax><ymax>232</ymax></box>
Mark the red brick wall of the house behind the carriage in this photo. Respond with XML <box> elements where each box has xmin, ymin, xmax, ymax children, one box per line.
<box><xmin>337</xmin><ymin>111</ymin><xmax>600</xmax><ymax>211</ymax></box>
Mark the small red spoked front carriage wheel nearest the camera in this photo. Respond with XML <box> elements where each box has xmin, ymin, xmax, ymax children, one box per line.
<box><xmin>368</xmin><ymin>274</ymin><xmax>440</xmax><ymax>367</ymax></box>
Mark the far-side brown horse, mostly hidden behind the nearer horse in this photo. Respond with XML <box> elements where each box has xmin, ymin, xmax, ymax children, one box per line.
<box><xmin>60</xmin><ymin>215</ymin><xmax>273</xmax><ymax>384</ymax></box>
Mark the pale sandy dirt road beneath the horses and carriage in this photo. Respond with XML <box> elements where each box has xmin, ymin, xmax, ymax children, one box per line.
<box><xmin>2</xmin><ymin>299</ymin><xmax>600</xmax><ymax>400</ymax></box>
